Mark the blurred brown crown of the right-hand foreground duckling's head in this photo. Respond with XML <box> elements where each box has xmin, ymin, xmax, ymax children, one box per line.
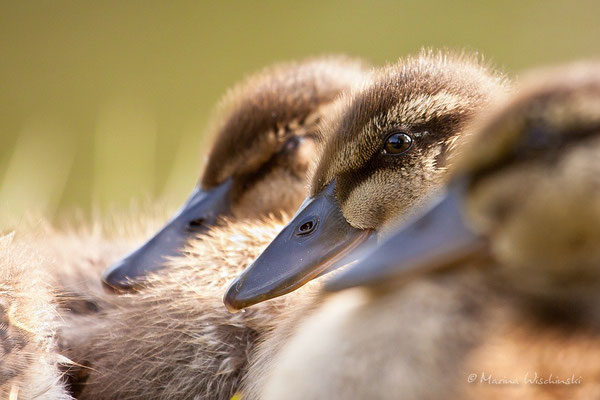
<box><xmin>453</xmin><ymin>62</ymin><xmax>600</xmax><ymax>179</ymax></box>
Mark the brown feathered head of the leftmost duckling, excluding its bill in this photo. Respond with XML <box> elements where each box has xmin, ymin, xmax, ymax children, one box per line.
<box><xmin>200</xmin><ymin>56</ymin><xmax>368</xmax><ymax>219</ymax></box>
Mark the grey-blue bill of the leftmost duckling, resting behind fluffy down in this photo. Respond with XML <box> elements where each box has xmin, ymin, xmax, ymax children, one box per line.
<box><xmin>102</xmin><ymin>180</ymin><xmax>232</xmax><ymax>291</ymax></box>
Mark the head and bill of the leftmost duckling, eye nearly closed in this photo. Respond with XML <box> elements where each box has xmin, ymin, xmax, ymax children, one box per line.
<box><xmin>102</xmin><ymin>57</ymin><xmax>366</xmax><ymax>291</ymax></box>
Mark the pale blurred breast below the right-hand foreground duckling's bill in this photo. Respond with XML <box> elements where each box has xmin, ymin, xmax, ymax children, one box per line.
<box><xmin>255</xmin><ymin>276</ymin><xmax>484</xmax><ymax>400</ymax></box>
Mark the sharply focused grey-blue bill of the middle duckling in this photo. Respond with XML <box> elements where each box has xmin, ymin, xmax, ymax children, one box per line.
<box><xmin>223</xmin><ymin>182</ymin><xmax>372</xmax><ymax>312</ymax></box>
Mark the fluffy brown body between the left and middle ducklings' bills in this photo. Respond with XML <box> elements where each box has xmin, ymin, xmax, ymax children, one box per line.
<box><xmin>70</xmin><ymin>219</ymin><xmax>324</xmax><ymax>399</ymax></box>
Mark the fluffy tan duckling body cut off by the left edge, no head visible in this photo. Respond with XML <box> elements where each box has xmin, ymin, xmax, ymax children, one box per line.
<box><xmin>0</xmin><ymin>234</ymin><xmax>71</xmax><ymax>400</ymax></box>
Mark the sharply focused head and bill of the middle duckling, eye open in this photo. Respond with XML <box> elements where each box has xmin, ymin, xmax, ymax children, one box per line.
<box><xmin>224</xmin><ymin>52</ymin><xmax>503</xmax><ymax>311</ymax></box>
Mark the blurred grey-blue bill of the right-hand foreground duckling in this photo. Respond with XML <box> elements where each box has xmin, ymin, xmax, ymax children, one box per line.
<box><xmin>325</xmin><ymin>185</ymin><xmax>485</xmax><ymax>292</ymax></box>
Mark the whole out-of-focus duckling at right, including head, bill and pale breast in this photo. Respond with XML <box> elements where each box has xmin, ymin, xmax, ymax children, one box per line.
<box><xmin>261</xmin><ymin>64</ymin><xmax>600</xmax><ymax>400</ymax></box>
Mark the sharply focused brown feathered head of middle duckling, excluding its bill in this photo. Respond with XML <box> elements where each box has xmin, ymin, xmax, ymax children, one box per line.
<box><xmin>310</xmin><ymin>51</ymin><xmax>506</xmax><ymax>229</ymax></box>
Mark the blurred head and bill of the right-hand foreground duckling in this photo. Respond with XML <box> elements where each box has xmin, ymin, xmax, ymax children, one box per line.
<box><xmin>327</xmin><ymin>64</ymin><xmax>600</xmax><ymax>296</ymax></box>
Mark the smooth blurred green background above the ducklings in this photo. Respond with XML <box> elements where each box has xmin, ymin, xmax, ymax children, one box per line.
<box><xmin>0</xmin><ymin>0</ymin><xmax>600</xmax><ymax>220</ymax></box>
